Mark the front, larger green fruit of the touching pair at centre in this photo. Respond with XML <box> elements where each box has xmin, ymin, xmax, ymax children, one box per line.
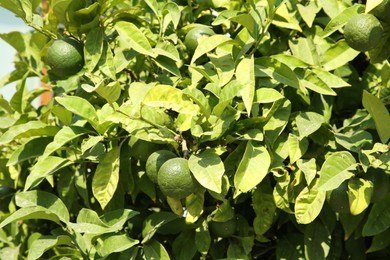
<box><xmin>157</xmin><ymin>158</ymin><xmax>197</xmax><ymax>199</ymax></box>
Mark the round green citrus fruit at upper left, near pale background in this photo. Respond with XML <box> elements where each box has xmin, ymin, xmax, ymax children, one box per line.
<box><xmin>47</xmin><ymin>38</ymin><xmax>84</xmax><ymax>78</ymax></box>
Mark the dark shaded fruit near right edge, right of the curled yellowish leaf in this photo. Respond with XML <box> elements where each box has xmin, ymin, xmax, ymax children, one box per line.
<box><xmin>365</xmin><ymin>168</ymin><xmax>390</xmax><ymax>203</ymax></box>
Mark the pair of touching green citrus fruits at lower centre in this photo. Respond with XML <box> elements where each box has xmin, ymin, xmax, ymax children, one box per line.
<box><xmin>146</xmin><ymin>150</ymin><xmax>197</xmax><ymax>199</ymax></box>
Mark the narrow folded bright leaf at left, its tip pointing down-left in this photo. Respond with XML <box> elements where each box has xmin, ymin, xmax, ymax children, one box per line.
<box><xmin>24</xmin><ymin>156</ymin><xmax>73</xmax><ymax>191</ymax></box>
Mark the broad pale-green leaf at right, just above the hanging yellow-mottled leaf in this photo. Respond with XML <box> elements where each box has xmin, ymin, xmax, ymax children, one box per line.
<box><xmin>318</xmin><ymin>151</ymin><xmax>356</xmax><ymax>191</ymax></box>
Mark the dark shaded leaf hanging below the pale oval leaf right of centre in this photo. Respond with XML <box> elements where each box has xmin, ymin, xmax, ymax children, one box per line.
<box><xmin>252</xmin><ymin>185</ymin><xmax>277</xmax><ymax>236</ymax></box>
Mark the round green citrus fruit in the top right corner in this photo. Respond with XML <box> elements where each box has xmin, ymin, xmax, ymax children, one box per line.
<box><xmin>344</xmin><ymin>14</ymin><xmax>383</xmax><ymax>51</ymax></box>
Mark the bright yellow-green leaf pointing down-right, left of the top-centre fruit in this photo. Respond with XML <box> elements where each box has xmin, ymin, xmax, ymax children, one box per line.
<box><xmin>115</xmin><ymin>21</ymin><xmax>155</xmax><ymax>57</ymax></box>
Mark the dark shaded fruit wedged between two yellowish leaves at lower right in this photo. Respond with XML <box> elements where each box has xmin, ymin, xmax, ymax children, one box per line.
<box><xmin>327</xmin><ymin>180</ymin><xmax>351</xmax><ymax>213</ymax></box>
